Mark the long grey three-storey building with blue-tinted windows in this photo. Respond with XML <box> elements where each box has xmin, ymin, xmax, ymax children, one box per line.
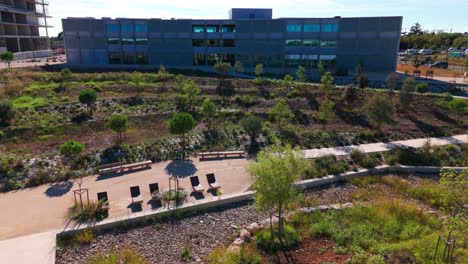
<box><xmin>62</xmin><ymin>9</ymin><xmax>402</xmax><ymax>74</ymax></box>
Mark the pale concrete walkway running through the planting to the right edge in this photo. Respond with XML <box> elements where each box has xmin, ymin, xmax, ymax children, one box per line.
<box><xmin>304</xmin><ymin>134</ymin><xmax>468</xmax><ymax>159</ymax></box>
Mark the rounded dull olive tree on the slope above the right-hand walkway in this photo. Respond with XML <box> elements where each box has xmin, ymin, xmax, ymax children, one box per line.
<box><xmin>364</xmin><ymin>94</ymin><xmax>393</xmax><ymax>130</ymax></box>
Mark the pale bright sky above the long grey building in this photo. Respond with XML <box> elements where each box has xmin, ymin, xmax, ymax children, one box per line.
<box><xmin>49</xmin><ymin>0</ymin><xmax>468</xmax><ymax>36</ymax></box>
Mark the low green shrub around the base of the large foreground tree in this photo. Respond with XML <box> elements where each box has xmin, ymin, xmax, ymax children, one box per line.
<box><xmin>255</xmin><ymin>225</ymin><xmax>301</xmax><ymax>253</ymax></box>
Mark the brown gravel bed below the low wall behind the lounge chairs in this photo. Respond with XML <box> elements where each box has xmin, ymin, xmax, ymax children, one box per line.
<box><xmin>56</xmin><ymin>204</ymin><xmax>268</xmax><ymax>264</ymax></box>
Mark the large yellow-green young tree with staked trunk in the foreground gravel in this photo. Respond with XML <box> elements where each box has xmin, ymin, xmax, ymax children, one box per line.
<box><xmin>248</xmin><ymin>146</ymin><xmax>310</xmax><ymax>243</ymax></box>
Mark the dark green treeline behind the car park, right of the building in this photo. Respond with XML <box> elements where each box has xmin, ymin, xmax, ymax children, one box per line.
<box><xmin>400</xmin><ymin>23</ymin><xmax>468</xmax><ymax>51</ymax></box>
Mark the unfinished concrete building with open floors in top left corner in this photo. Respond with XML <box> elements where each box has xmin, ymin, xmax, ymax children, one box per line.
<box><xmin>0</xmin><ymin>0</ymin><xmax>52</xmax><ymax>53</ymax></box>
